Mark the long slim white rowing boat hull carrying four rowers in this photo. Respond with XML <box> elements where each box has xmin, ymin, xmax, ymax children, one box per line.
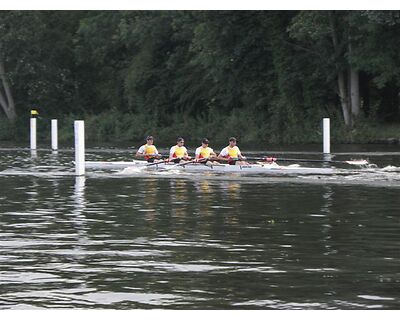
<box><xmin>85</xmin><ymin>160</ymin><xmax>337</xmax><ymax>174</ymax></box>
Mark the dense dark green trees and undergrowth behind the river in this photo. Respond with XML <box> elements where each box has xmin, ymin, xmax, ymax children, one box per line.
<box><xmin>0</xmin><ymin>11</ymin><xmax>400</xmax><ymax>143</ymax></box>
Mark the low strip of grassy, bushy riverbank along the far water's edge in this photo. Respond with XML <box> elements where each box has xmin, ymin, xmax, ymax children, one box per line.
<box><xmin>0</xmin><ymin>113</ymin><xmax>400</xmax><ymax>146</ymax></box>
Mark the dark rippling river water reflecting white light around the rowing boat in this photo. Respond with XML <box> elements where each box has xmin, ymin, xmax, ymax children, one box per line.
<box><xmin>0</xmin><ymin>148</ymin><xmax>400</xmax><ymax>309</ymax></box>
